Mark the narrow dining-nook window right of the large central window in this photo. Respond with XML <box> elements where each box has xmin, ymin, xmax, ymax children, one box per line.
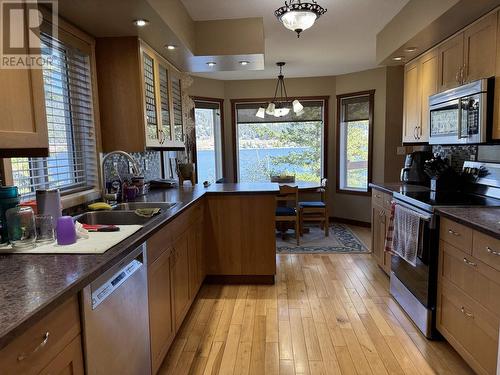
<box><xmin>337</xmin><ymin>92</ymin><xmax>373</xmax><ymax>192</ymax></box>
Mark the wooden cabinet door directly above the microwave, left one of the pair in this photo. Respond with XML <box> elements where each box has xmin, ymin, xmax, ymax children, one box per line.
<box><xmin>438</xmin><ymin>33</ymin><xmax>464</xmax><ymax>91</ymax></box>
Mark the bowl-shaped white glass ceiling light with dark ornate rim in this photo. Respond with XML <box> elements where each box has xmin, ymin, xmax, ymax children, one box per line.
<box><xmin>274</xmin><ymin>0</ymin><xmax>326</xmax><ymax>38</ymax></box>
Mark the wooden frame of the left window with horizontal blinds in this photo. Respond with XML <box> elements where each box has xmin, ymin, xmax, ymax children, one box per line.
<box><xmin>0</xmin><ymin>13</ymin><xmax>102</xmax><ymax>209</ymax></box>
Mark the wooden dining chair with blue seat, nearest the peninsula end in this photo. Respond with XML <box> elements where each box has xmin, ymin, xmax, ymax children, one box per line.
<box><xmin>275</xmin><ymin>185</ymin><xmax>300</xmax><ymax>246</ymax></box>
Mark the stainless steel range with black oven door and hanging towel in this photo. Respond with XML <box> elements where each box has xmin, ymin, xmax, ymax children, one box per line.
<box><xmin>390</xmin><ymin>162</ymin><xmax>500</xmax><ymax>338</ymax></box>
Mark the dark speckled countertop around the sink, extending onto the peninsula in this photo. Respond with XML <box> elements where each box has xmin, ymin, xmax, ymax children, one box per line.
<box><xmin>0</xmin><ymin>183</ymin><xmax>279</xmax><ymax>349</ymax></box>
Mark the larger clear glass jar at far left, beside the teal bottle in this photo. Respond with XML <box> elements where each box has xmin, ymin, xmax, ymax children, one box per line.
<box><xmin>6</xmin><ymin>206</ymin><xmax>36</xmax><ymax>249</ymax></box>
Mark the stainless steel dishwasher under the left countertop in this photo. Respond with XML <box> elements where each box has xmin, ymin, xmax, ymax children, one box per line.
<box><xmin>82</xmin><ymin>244</ymin><xmax>151</xmax><ymax>375</ymax></box>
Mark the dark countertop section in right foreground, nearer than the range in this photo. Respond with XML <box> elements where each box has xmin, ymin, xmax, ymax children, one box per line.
<box><xmin>437</xmin><ymin>207</ymin><xmax>500</xmax><ymax>239</ymax></box>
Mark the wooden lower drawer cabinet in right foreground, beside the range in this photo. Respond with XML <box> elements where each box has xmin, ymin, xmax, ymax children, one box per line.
<box><xmin>436</xmin><ymin>220</ymin><xmax>500</xmax><ymax>374</ymax></box>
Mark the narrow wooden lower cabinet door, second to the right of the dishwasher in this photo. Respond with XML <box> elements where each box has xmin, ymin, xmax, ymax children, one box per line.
<box><xmin>172</xmin><ymin>231</ymin><xmax>190</xmax><ymax>331</ymax></box>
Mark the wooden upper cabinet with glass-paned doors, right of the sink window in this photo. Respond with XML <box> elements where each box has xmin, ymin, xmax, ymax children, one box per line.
<box><xmin>96</xmin><ymin>37</ymin><xmax>184</xmax><ymax>152</ymax></box>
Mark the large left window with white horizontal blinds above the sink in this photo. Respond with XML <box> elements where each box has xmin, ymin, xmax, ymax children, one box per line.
<box><xmin>11</xmin><ymin>34</ymin><xmax>98</xmax><ymax>198</ymax></box>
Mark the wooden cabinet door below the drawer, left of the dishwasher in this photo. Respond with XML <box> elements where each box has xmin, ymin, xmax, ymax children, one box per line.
<box><xmin>40</xmin><ymin>335</ymin><xmax>84</xmax><ymax>375</ymax></box>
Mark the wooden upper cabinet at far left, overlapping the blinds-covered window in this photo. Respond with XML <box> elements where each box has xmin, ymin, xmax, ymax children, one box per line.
<box><xmin>0</xmin><ymin>59</ymin><xmax>49</xmax><ymax>156</ymax></box>
